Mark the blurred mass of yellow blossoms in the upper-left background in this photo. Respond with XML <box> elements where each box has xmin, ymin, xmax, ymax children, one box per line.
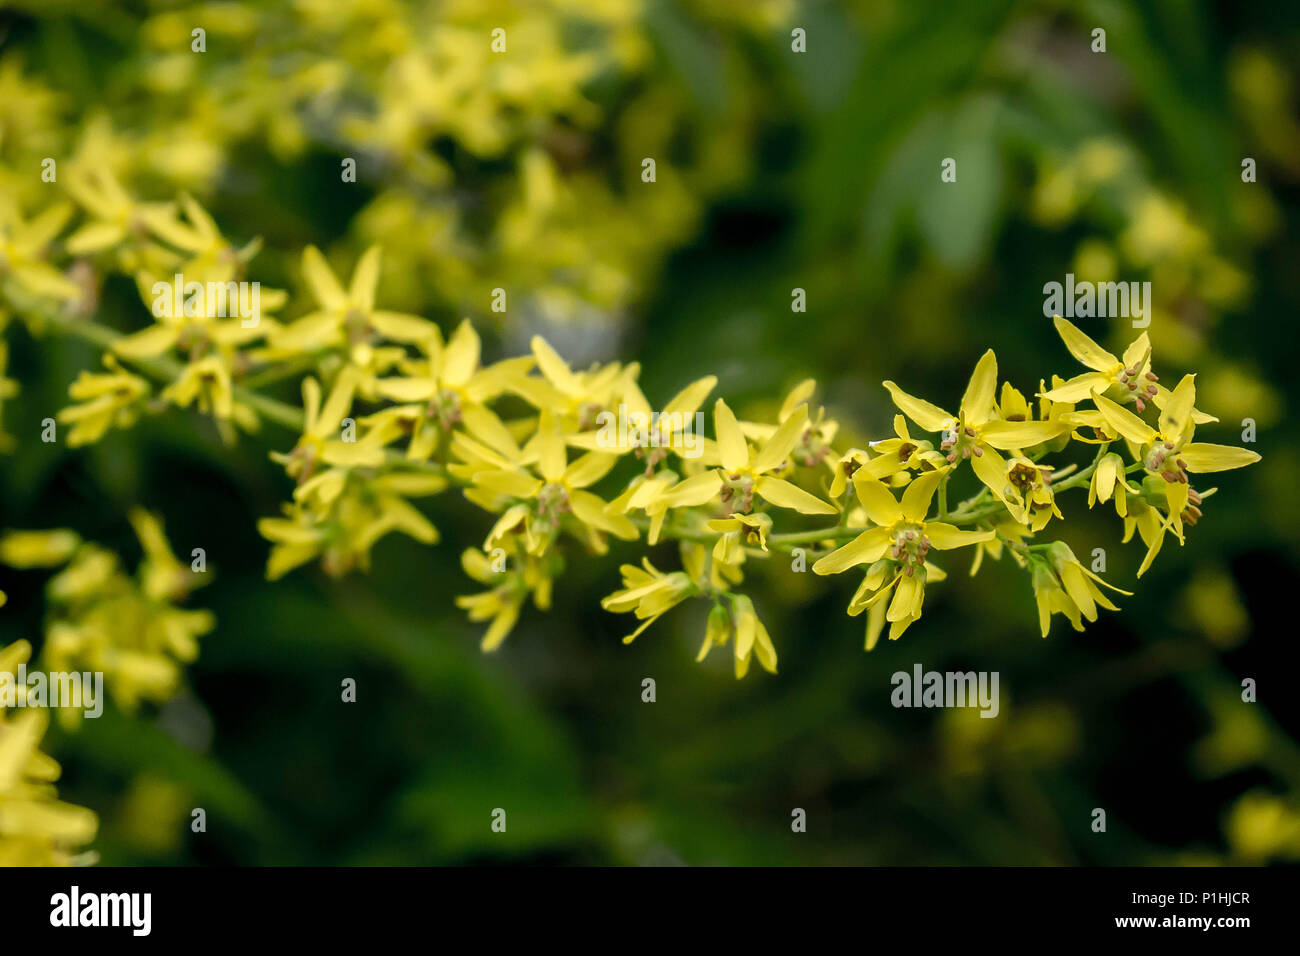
<box><xmin>0</xmin><ymin>0</ymin><xmax>793</xmax><ymax>335</ymax></box>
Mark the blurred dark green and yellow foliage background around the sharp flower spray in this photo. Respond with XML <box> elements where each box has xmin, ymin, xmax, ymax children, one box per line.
<box><xmin>0</xmin><ymin>0</ymin><xmax>1300</xmax><ymax>865</ymax></box>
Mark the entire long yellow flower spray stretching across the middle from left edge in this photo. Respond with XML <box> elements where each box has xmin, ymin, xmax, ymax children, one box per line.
<box><xmin>4</xmin><ymin>162</ymin><xmax>1258</xmax><ymax>674</ymax></box>
